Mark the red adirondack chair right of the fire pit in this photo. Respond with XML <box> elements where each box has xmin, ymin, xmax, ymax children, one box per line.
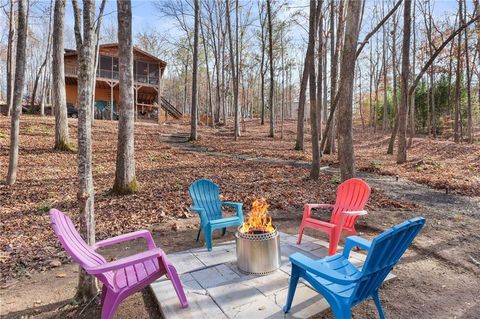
<box><xmin>297</xmin><ymin>178</ymin><xmax>370</xmax><ymax>255</ymax></box>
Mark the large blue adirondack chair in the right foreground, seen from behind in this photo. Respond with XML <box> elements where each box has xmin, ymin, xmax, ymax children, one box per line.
<box><xmin>283</xmin><ymin>217</ymin><xmax>425</xmax><ymax>319</ymax></box>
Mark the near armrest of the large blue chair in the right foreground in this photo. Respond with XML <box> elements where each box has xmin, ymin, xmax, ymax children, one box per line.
<box><xmin>289</xmin><ymin>253</ymin><xmax>360</xmax><ymax>284</ymax></box>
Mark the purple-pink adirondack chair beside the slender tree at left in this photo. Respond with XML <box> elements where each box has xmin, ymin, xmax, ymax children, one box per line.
<box><xmin>50</xmin><ymin>209</ymin><xmax>188</xmax><ymax>319</ymax></box>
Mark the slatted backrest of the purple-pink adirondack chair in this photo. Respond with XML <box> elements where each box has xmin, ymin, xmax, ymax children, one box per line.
<box><xmin>50</xmin><ymin>209</ymin><xmax>113</xmax><ymax>284</ymax></box>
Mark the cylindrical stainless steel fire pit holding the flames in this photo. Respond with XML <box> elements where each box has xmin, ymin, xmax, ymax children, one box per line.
<box><xmin>235</xmin><ymin>226</ymin><xmax>280</xmax><ymax>275</ymax></box>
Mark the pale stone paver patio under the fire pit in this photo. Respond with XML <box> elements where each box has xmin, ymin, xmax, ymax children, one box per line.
<box><xmin>151</xmin><ymin>233</ymin><xmax>393</xmax><ymax>319</ymax></box>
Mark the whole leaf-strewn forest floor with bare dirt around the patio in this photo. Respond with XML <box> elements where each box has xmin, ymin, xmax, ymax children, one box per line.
<box><xmin>0</xmin><ymin>116</ymin><xmax>480</xmax><ymax>319</ymax></box>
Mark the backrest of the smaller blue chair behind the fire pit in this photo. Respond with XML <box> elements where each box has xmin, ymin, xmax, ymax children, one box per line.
<box><xmin>188</xmin><ymin>179</ymin><xmax>222</xmax><ymax>220</ymax></box>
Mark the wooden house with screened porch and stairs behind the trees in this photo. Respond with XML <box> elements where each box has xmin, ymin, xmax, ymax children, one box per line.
<box><xmin>65</xmin><ymin>43</ymin><xmax>182</xmax><ymax>118</ymax></box>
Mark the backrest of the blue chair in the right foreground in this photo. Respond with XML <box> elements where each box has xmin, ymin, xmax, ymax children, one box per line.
<box><xmin>352</xmin><ymin>217</ymin><xmax>425</xmax><ymax>304</ymax></box>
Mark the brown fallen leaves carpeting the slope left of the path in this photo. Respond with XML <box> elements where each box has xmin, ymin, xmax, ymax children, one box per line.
<box><xmin>0</xmin><ymin>116</ymin><xmax>414</xmax><ymax>282</ymax></box>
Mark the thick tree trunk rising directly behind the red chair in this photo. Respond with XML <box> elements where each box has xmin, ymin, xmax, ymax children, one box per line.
<box><xmin>338</xmin><ymin>0</ymin><xmax>362</xmax><ymax>180</ymax></box>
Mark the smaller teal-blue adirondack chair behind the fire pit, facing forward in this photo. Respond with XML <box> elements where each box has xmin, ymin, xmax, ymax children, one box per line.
<box><xmin>188</xmin><ymin>179</ymin><xmax>243</xmax><ymax>250</ymax></box>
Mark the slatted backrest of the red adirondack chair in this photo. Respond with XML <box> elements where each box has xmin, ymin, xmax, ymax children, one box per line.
<box><xmin>330</xmin><ymin>178</ymin><xmax>370</xmax><ymax>229</ymax></box>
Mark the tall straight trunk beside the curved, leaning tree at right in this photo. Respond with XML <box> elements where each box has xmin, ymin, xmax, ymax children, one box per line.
<box><xmin>397</xmin><ymin>0</ymin><xmax>412</xmax><ymax>164</ymax></box>
